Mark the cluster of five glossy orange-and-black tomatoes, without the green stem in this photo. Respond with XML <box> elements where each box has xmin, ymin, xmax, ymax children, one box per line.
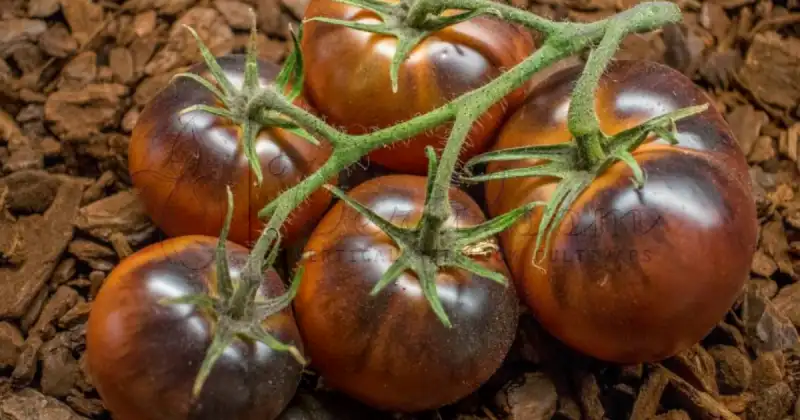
<box><xmin>87</xmin><ymin>0</ymin><xmax>756</xmax><ymax>420</ymax></box>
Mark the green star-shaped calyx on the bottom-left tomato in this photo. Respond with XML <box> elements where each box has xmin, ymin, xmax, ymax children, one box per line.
<box><xmin>161</xmin><ymin>188</ymin><xmax>308</xmax><ymax>398</ymax></box>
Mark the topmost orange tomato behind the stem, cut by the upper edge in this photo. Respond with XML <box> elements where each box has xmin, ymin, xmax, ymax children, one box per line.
<box><xmin>302</xmin><ymin>0</ymin><xmax>534</xmax><ymax>174</ymax></box>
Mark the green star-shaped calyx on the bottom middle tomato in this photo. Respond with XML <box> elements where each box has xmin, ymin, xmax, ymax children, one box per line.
<box><xmin>325</xmin><ymin>146</ymin><xmax>540</xmax><ymax>328</ymax></box>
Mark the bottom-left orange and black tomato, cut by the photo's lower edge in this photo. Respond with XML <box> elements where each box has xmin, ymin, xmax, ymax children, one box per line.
<box><xmin>86</xmin><ymin>236</ymin><xmax>302</xmax><ymax>420</ymax></box>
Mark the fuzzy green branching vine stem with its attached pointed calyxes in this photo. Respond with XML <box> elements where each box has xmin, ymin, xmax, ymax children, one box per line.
<box><xmin>170</xmin><ymin>0</ymin><xmax>700</xmax><ymax>380</ymax></box>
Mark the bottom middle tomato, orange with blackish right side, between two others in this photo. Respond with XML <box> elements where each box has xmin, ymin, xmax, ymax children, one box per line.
<box><xmin>294</xmin><ymin>175</ymin><xmax>518</xmax><ymax>412</ymax></box>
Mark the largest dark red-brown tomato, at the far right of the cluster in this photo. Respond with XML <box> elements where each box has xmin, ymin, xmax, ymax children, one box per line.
<box><xmin>485</xmin><ymin>61</ymin><xmax>758</xmax><ymax>363</ymax></box>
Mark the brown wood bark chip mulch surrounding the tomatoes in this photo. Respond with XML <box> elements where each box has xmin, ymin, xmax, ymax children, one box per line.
<box><xmin>0</xmin><ymin>0</ymin><xmax>800</xmax><ymax>420</ymax></box>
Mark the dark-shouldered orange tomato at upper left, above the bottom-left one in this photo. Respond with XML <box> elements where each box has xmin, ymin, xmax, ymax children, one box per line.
<box><xmin>128</xmin><ymin>55</ymin><xmax>331</xmax><ymax>246</ymax></box>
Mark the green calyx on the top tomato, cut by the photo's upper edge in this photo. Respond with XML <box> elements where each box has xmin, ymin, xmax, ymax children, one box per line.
<box><xmin>306</xmin><ymin>0</ymin><xmax>502</xmax><ymax>93</ymax></box>
